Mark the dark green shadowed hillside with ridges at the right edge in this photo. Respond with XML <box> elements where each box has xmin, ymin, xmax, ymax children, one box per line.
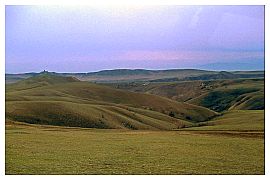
<box><xmin>188</xmin><ymin>79</ymin><xmax>264</xmax><ymax>112</ymax></box>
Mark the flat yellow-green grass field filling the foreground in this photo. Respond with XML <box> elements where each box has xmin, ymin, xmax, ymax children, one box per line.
<box><xmin>6</xmin><ymin>121</ymin><xmax>264</xmax><ymax>174</ymax></box>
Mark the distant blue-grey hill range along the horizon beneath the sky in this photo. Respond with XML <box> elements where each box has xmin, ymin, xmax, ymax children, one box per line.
<box><xmin>6</xmin><ymin>69</ymin><xmax>264</xmax><ymax>83</ymax></box>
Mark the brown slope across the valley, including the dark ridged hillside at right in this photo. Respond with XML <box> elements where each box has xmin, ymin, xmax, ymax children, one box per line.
<box><xmin>107</xmin><ymin>78</ymin><xmax>264</xmax><ymax>112</ymax></box>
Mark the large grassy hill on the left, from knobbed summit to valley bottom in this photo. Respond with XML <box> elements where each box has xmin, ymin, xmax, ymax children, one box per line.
<box><xmin>6</xmin><ymin>75</ymin><xmax>217</xmax><ymax>130</ymax></box>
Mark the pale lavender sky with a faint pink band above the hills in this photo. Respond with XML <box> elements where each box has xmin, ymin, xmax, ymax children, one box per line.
<box><xmin>5</xmin><ymin>5</ymin><xmax>264</xmax><ymax>73</ymax></box>
